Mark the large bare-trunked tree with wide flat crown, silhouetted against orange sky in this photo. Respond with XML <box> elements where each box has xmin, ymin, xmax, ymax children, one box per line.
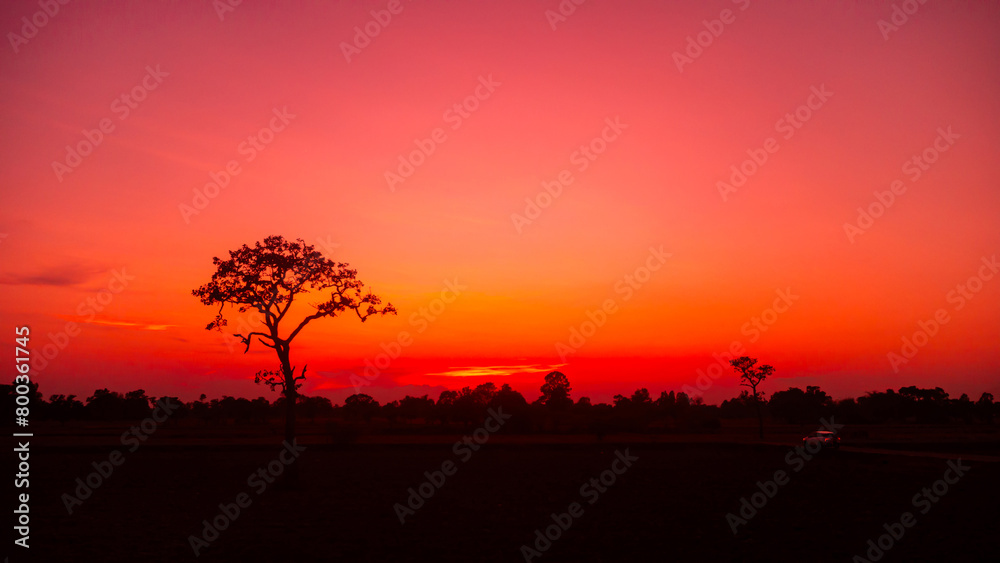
<box><xmin>192</xmin><ymin>236</ymin><xmax>396</xmax><ymax>443</ymax></box>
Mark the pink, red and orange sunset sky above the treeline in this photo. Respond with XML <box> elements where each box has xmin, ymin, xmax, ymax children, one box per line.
<box><xmin>0</xmin><ymin>0</ymin><xmax>1000</xmax><ymax>403</ymax></box>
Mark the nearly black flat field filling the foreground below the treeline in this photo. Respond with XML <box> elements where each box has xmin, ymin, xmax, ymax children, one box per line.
<box><xmin>19</xmin><ymin>436</ymin><xmax>1000</xmax><ymax>562</ymax></box>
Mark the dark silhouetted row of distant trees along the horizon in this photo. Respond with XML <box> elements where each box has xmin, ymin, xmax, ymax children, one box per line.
<box><xmin>2</xmin><ymin>372</ymin><xmax>1000</xmax><ymax>434</ymax></box>
